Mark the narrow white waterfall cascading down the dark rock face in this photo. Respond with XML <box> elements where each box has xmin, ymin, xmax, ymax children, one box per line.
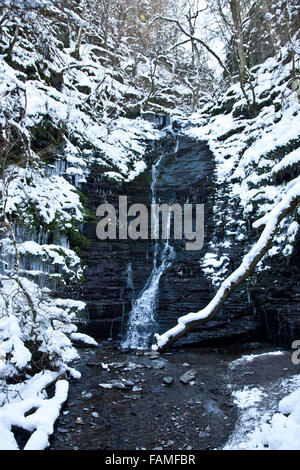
<box><xmin>121</xmin><ymin>156</ymin><xmax>175</xmax><ymax>349</ymax></box>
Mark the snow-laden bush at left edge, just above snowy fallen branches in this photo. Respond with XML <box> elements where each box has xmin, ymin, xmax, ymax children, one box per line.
<box><xmin>0</xmin><ymin>276</ymin><xmax>85</xmax><ymax>379</ymax></box>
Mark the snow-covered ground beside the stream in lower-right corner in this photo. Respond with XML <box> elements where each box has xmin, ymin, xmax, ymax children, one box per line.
<box><xmin>224</xmin><ymin>351</ymin><xmax>300</xmax><ymax>450</ymax></box>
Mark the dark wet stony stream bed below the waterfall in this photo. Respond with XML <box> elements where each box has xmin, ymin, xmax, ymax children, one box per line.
<box><xmin>50</xmin><ymin>342</ymin><xmax>299</xmax><ymax>450</ymax></box>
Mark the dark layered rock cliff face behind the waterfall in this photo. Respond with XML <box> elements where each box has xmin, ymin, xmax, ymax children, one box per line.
<box><xmin>80</xmin><ymin>122</ymin><xmax>262</xmax><ymax>345</ymax></box>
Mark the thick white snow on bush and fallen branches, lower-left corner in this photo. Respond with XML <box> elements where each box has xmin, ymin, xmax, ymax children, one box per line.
<box><xmin>0</xmin><ymin>274</ymin><xmax>91</xmax><ymax>450</ymax></box>
